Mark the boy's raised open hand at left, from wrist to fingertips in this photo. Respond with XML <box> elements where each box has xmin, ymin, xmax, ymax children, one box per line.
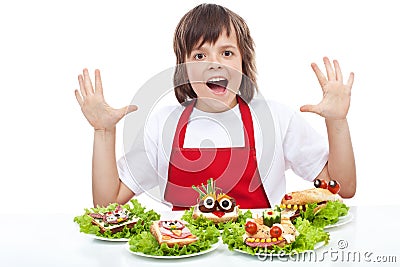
<box><xmin>75</xmin><ymin>69</ymin><xmax>137</xmax><ymax>130</ymax></box>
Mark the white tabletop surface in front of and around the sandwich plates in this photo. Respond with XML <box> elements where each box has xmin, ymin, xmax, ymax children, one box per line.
<box><xmin>0</xmin><ymin>206</ymin><xmax>400</xmax><ymax>267</ymax></box>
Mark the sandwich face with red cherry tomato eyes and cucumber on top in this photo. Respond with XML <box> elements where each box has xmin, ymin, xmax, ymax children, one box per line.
<box><xmin>243</xmin><ymin>207</ymin><xmax>299</xmax><ymax>249</ymax></box>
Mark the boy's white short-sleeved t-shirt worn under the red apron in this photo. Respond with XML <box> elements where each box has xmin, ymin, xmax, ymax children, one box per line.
<box><xmin>117</xmin><ymin>98</ymin><xmax>328</xmax><ymax>205</ymax></box>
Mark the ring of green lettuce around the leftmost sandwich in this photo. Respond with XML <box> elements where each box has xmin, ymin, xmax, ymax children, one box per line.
<box><xmin>74</xmin><ymin>199</ymin><xmax>160</xmax><ymax>239</ymax></box>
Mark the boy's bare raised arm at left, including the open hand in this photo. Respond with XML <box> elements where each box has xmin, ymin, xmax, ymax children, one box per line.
<box><xmin>75</xmin><ymin>69</ymin><xmax>137</xmax><ymax>206</ymax></box>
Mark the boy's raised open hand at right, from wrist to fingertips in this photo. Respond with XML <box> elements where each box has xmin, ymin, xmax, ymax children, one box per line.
<box><xmin>300</xmin><ymin>57</ymin><xmax>354</xmax><ymax>120</ymax></box>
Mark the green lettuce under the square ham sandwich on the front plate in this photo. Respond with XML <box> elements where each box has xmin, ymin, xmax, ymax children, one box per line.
<box><xmin>129</xmin><ymin>224</ymin><xmax>219</xmax><ymax>256</ymax></box>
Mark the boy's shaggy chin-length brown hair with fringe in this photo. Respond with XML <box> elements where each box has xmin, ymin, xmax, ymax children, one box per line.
<box><xmin>174</xmin><ymin>4</ymin><xmax>257</xmax><ymax>103</ymax></box>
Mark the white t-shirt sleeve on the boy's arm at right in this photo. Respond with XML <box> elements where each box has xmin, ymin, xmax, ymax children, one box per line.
<box><xmin>283</xmin><ymin>112</ymin><xmax>329</xmax><ymax>181</ymax></box>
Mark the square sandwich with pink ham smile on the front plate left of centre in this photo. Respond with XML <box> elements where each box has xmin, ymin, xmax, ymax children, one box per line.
<box><xmin>150</xmin><ymin>220</ymin><xmax>198</xmax><ymax>247</ymax></box>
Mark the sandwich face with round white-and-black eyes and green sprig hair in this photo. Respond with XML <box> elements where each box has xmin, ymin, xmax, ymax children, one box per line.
<box><xmin>192</xmin><ymin>178</ymin><xmax>239</xmax><ymax>224</ymax></box>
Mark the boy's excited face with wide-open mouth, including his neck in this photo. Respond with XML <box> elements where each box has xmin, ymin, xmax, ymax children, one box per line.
<box><xmin>186</xmin><ymin>29</ymin><xmax>242</xmax><ymax>112</ymax></box>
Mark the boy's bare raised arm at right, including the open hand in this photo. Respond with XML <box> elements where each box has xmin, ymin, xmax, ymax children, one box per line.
<box><xmin>300</xmin><ymin>57</ymin><xmax>356</xmax><ymax>198</ymax></box>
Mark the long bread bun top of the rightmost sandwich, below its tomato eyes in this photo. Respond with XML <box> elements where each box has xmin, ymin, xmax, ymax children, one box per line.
<box><xmin>281</xmin><ymin>188</ymin><xmax>343</xmax><ymax>206</ymax></box>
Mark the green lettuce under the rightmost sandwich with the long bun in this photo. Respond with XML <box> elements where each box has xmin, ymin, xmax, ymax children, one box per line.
<box><xmin>300</xmin><ymin>201</ymin><xmax>349</xmax><ymax>228</ymax></box>
